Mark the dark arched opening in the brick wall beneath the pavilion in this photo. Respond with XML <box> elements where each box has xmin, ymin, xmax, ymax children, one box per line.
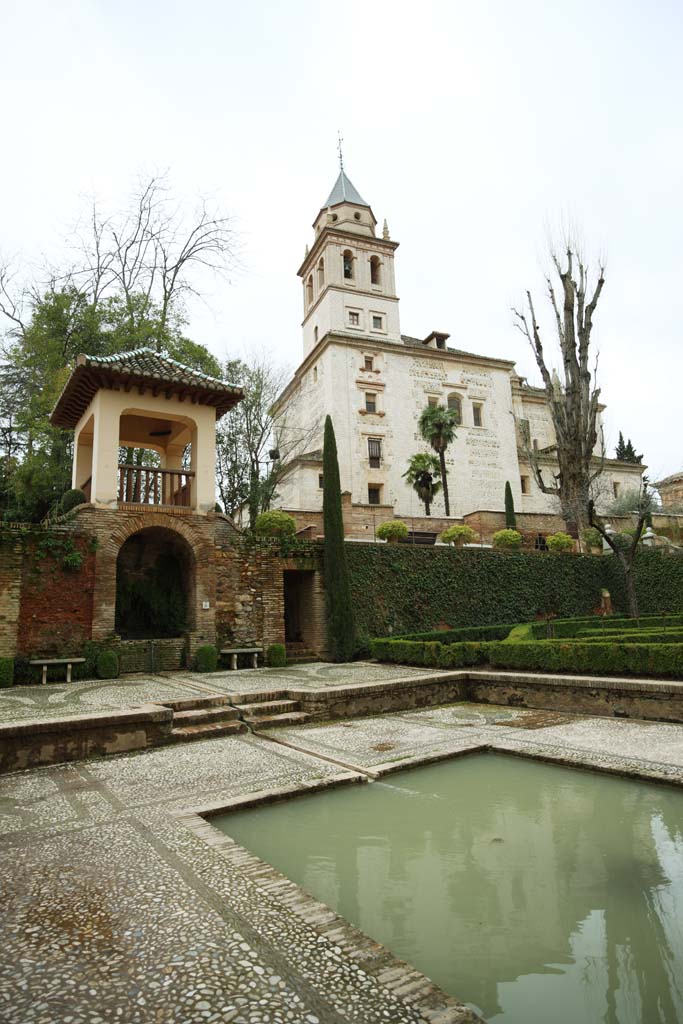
<box><xmin>116</xmin><ymin>526</ymin><xmax>196</xmax><ymax>640</ymax></box>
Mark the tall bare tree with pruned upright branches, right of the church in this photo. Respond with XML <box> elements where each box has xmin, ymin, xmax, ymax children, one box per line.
<box><xmin>513</xmin><ymin>247</ymin><xmax>605</xmax><ymax>527</ymax></box>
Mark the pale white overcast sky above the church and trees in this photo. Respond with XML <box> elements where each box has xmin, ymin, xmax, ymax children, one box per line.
<box><xmin>0</xmin><ymin>0</ymin><xmax>683</xmax><ymax>479</ymax></box>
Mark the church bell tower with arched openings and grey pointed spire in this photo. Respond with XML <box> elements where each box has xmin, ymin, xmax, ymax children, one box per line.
<box><xmin>298</xmin><ymin>164</ymin><xmax>400</xmax><ymax>357</ymax></box>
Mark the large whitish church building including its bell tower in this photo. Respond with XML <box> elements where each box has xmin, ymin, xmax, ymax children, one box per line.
<box><xmin>275</xmin><ymin>169</ymin><xmax>643</xmax><ymax>528</ymax></box>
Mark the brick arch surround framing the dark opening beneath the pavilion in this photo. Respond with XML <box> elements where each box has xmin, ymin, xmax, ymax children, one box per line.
<box><xmin>92</xmin><ymin>510</ymin><xmax>216</xmax><ymax>646</ymax></box>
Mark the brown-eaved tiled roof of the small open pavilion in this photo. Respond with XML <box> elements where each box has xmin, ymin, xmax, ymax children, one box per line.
<box><xmin>50</xmin><ymin>348</ymin><xmax>243</xmax><ymax>427</ymax></box>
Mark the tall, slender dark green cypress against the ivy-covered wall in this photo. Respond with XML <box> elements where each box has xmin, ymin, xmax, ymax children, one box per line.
<box><xmin>323</xmin><ymin>416</ymin><xmax>355</xmax><ymax>662</ymax></box>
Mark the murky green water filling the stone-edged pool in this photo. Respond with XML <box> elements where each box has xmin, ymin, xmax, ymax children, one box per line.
<box><xmin>212</xmin><ymin>754</ymin><xmax>683</xmax><ymax>1024</ymax></box>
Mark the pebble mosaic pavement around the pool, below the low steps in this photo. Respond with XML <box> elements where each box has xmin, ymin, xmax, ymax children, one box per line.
<box><xmin>0</xmin><ymin>670</ymin><xmax>683</xmax><ymax>1024</ymax></box>
